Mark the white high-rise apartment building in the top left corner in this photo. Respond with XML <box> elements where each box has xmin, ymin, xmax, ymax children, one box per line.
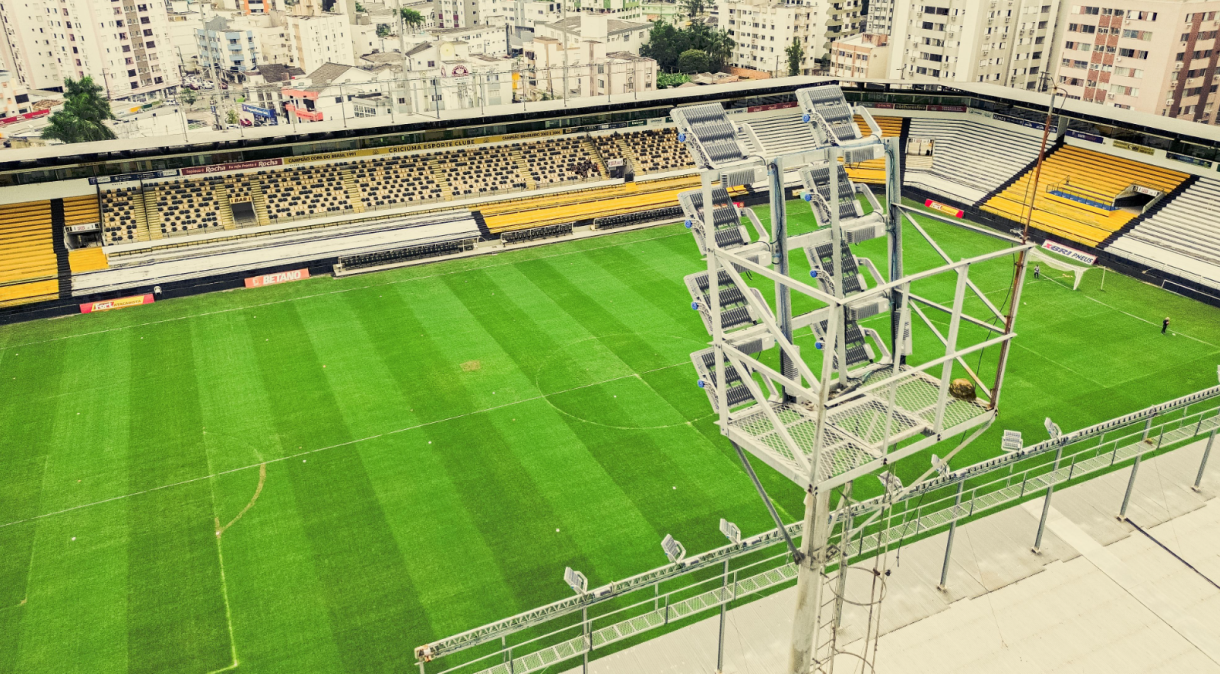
<box><xmin>0</xmin><ymin>0</ymin><xmax>181</xmax><ymax>100</ymax></box>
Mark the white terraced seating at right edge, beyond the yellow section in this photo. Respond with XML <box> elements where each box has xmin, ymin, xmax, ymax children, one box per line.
<box><xmin>1107</xmin><ymin>178</ymin><xmax>1220</xmax><ymax>271</ymax></box>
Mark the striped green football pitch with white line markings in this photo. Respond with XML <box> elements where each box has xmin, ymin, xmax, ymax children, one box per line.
<box><xmin>0</xmin><ymin>197</ymin><xmax>1220</xmax><ymax>674</ymax></box>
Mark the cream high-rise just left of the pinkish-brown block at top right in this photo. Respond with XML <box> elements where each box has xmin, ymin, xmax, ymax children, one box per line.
<box><xmin>889</xmin><ymin>0</ymin><xmax>1070</xmax><ymax>89</ymax></box>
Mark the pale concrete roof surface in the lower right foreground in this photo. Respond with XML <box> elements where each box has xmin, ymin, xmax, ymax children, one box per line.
<box><xmin>575</xmin><ymin>434</ymin><xmax>1220</xmax><ymax>674</ymax></box>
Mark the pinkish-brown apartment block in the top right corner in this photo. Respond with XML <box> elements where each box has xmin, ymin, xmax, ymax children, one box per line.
<box><xmin>1055</xmin><ymin>0</ymin><xmax>1220</xmax><ymax>123</ymax></box>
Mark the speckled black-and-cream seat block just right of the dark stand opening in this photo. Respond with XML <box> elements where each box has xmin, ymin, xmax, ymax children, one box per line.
<box><xmin>259</xmin><ymin>164</ymin><xmax>354</xmax><ymax>223</ymax></box>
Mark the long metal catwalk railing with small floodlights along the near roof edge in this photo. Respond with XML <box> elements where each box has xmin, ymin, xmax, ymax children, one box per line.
<box><xmin>416</xmin><ymin>386</ymin><xmax>1220</xmax><ymax>674</ymax></box>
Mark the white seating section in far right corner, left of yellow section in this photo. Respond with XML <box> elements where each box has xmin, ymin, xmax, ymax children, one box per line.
<box><xmin>904</xmin><ymin>117</ymin><xmax>1039</xmax><ymax>205</ymax></box>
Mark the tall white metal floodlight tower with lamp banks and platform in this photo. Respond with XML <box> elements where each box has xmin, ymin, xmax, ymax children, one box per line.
<box><xmin>671</xmin><ymin>85</ymin><xmax>1030</xmax><ymax>674</ymax></box>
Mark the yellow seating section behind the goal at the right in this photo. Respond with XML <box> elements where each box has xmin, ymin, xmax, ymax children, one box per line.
<box><xmin>982</xmin><ymin>145</ymin><xmax>1187</xmax><ymax>245</ymax></box>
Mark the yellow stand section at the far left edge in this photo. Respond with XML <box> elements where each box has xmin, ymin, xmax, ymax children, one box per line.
<box><xmin>0</xmin><ymin>201</ymin><xmax>60</xmax><ymax>306</ymax></box>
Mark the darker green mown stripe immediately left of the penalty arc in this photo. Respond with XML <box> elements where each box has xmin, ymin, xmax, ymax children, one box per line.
<box><xmin>124</xmin><ymin>322</ymin><xmax>231</xmax><ymax>674</ymax></box>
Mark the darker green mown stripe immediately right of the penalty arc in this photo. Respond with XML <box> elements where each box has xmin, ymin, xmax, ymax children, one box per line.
<box><xmin>249</xmin><ymin>304</ymin><xmax>428</xmax><ymax>673</ymax></box>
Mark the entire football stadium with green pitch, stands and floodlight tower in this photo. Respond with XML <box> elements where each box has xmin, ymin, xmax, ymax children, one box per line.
<box><xmin>0</xmin><ymin>77</ymin><xmax>1220</xmax><ymax>674</ymax></box>
